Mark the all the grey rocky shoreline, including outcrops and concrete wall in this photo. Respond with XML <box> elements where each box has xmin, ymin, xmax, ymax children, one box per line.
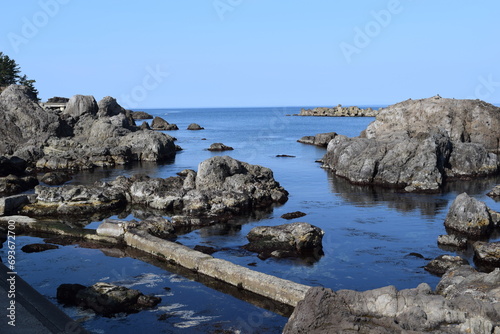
<box><xmin>0</xmin><ymin>86</ymin><xmax>500</xmax><ymax>333</ymax></box>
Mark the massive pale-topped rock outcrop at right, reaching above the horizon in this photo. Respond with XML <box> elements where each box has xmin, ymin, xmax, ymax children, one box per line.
<box><xmin>323</xmin><ymin>96</ymin><xmax>500</xmax><ymax>191</ymax></box>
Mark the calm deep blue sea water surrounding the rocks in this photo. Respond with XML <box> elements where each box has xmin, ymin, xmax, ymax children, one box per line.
<box><xmin>0</xmin><ymin>107</ymin><xmax>500</xmax><ymax>333</ymax></box>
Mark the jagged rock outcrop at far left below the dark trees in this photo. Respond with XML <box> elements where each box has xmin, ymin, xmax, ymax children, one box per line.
<box><xmin>0</xmin><ymin>85</ymin><xmax>175</xmax><ymax>170</ymax></box>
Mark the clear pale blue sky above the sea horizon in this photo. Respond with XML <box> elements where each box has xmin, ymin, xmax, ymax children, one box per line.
<box><xmin>0</xmin><ymin>0</ymin><xmax>500</xmax><ymax>109</ymax></box>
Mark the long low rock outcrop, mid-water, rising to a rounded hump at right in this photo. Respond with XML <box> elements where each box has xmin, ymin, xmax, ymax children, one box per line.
<box><xmin>21</xmin><ymin>156</ymin><xmax>288</xmax><ymax>225</ymax></box>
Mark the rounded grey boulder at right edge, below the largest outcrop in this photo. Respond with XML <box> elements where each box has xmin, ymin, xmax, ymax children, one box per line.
<box><xmin>444</xmin><ymin>193</ymin><xmax>494</xmax><ymax>237</ymax></box>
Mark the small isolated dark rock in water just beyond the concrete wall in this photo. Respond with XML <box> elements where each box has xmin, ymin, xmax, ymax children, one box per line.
<box><xmin>244</xmin><ymin>223</ymin><xmax>324</xmax><ymax>259</ymax></box>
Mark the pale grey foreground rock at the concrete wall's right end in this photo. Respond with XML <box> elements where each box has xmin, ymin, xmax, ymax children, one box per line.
<box><xmin>283</xmin><ymin>266</ymin><xmax>500</xmax><ymax>334</ymax></box>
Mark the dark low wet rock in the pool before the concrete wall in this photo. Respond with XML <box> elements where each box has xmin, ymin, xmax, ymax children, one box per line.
<box><xmin>57</xmin><ymin>282</ymin><xmax>161</xmax><ymax>317</ymax></box>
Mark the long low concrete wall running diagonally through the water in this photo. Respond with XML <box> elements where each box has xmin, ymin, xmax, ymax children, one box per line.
<box><xmin>0</xmin><ymin>216</ymin><xmax>311</xmax><ymax>307</ymax></box>
